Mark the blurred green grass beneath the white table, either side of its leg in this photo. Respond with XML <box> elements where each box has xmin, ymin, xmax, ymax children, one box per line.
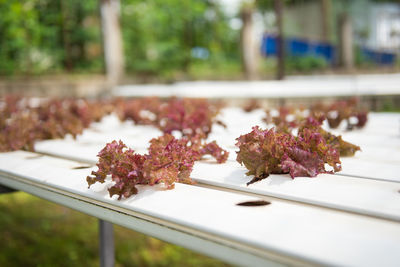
<box><xmin>0</xmin><ymin>192</ymin><xmax>228</xmax><ymax>267</ymax></box>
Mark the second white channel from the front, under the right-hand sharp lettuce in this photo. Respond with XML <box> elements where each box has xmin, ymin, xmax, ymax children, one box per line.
<box><xmin>32</xmin><ymin>135</ymin><xmax>400</xmax><ymax>220</ymax></box>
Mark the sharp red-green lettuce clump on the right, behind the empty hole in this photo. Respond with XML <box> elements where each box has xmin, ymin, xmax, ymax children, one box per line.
<box><xmin>236</xmin><ymin>126</ymin><xmax>341</xmax><ymax>185</ymax></box>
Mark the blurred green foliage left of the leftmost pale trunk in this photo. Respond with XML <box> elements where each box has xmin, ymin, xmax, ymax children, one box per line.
<box><xmin>0</xmin><ymin>0</ymin><xmax>102</xmax><ymax>75</ymax></box>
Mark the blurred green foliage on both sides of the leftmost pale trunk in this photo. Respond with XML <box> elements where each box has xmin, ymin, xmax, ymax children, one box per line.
<box><xmin>0</xmin><ymin>0</ymin><xmax>240</xmax><ymax>77</ymax></box>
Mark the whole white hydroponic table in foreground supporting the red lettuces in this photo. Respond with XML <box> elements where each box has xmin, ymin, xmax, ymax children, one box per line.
<box><xmin>0</xmin><ymin>109</ymin><xmax>400</xmax><ymax>266</ymax></box>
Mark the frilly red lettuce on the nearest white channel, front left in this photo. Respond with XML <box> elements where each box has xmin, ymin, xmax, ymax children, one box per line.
<box><xmin>86</xmin><ymin>134</ymin><xmax>228</xmax><ymax>199</ymax></box>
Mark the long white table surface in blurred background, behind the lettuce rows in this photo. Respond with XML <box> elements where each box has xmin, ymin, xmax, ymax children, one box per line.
<box><xmin>114</xmin><ymin>74</ymin><xmax>400</xmax><ymax>98</ymax></box>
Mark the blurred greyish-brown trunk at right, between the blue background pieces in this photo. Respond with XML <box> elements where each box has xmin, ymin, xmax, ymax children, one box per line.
<box><xmin>338</xmin><ymin>13</ymin><xmax>354</xmax><ymax>70</ymax></box>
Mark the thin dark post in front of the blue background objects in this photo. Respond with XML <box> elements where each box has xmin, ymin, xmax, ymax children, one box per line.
<box><xmin>274</xmin><ymin>0</ymin><xmax>285</xmax><ymax>80</ymax></box>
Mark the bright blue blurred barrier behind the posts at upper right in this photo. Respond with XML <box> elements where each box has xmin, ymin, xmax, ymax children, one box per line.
<box><xmin>261</xmin><ymin>34</ymin><xmax>396</xmax><ymax>65</ymax></box>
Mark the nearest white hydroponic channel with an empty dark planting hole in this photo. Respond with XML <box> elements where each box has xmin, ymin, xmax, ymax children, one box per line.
<box><xmin>0</xmin><ymin>151</ymin><xmax>400</xmax><ymax>266</ymax></box>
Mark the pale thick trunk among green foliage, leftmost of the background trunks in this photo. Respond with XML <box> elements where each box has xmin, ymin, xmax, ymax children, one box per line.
<box><xmin>100</xmin><ymin>0</ymin><xmax>124</xmax><ymax>87</ymax></box>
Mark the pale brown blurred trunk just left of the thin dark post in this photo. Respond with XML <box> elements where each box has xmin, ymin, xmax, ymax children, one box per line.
<box><xmin>240</xmin><ymin>5</ymin><xmax>257</xmax><ymax>80</ymax></box>
